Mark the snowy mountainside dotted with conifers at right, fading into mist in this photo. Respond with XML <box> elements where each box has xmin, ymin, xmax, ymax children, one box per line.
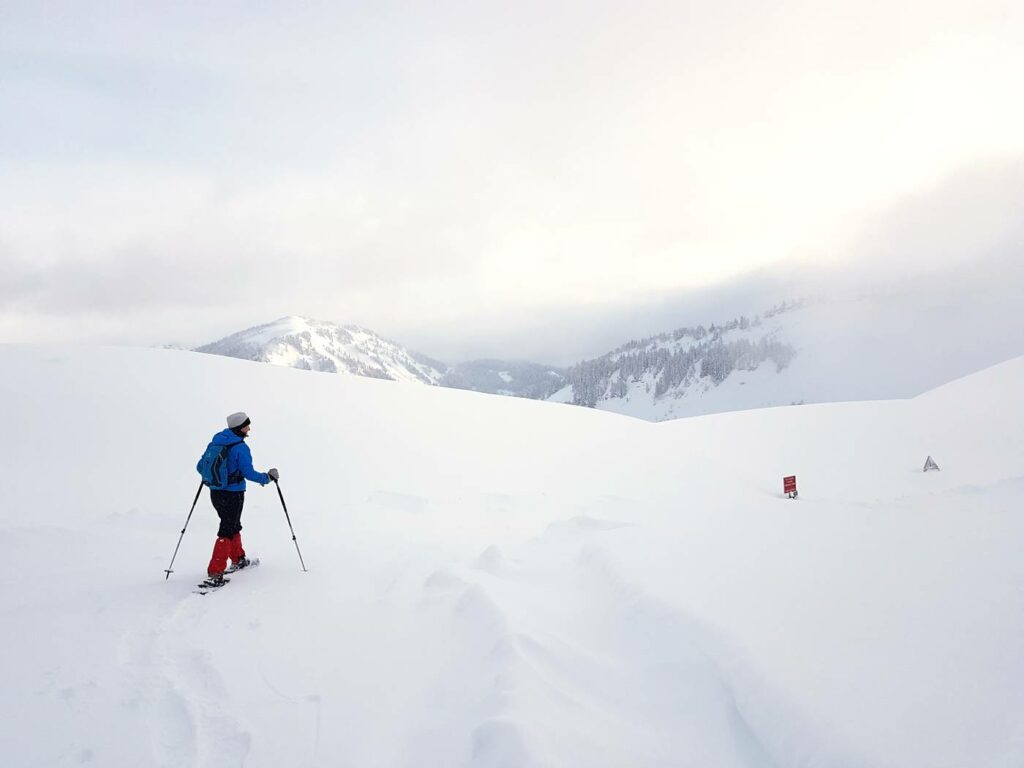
<box><xmin>550</xmin><ymin>290</ymin><xmax>1024</xmax><ymax>421</ymax></box>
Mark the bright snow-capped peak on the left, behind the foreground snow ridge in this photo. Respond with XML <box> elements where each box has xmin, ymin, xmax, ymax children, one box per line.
<box><xmin>196</xmin><ymin>315</ymin><xmax>447</xmax><ymax>384</ymax></box>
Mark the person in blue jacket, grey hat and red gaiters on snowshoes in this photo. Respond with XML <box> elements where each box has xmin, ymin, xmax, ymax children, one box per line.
<box><xmin>200</xmin><ymin>411</ymin><xmax>281</xmax><ymax>584</ymax></box>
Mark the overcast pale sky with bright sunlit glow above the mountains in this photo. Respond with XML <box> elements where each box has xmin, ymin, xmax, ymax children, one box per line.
<box><xmin>0</xmin><ymin>0</ymin><xmax>1024</xmax><ymax>362</ymax></box>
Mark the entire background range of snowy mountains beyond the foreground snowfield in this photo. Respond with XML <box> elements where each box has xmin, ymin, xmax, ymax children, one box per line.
<box><xmin>192</xmin><ymin>260</ymin><xmax>1024</xmax><ymax>428</ymax></box>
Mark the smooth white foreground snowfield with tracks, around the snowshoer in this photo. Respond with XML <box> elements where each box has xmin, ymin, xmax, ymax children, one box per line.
<box><xmin>0</xmin><ymin>346</ymin><xmax>1024</xmax><ymax>768</ymax></box>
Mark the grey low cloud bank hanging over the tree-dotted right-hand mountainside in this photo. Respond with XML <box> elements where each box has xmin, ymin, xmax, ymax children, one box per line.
<box><xmin>398</xmin><ymin>158</ymin><xmax>1024</xmax><ymax>366</ymax></box>
